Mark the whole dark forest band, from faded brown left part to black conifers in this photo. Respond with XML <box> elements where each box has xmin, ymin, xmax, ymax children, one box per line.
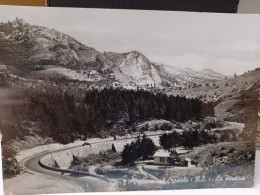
<box><xmin>0</xmin><ymin>87</ymin><xmax>213</xmax><ymax>143</ymax></box>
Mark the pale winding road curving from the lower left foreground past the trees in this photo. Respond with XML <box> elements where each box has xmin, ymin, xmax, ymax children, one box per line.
<box><xmin>5</xmin><ymin>133</ymin><xmax>181</xmax><ymax>195</ymax></box>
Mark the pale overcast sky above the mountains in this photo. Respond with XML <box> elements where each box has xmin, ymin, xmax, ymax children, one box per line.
<box><xmin>0</xmin><ymin>6</ymin><xmax>260</xmax><ymax>75</ymax></box>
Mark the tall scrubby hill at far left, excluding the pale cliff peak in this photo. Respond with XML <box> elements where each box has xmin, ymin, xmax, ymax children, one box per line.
<box><xmin>0</xmin><ymin>19</ymin><xmax>105</xmax><ymax>69</ymax></box>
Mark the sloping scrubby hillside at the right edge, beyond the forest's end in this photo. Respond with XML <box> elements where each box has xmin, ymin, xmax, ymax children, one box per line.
<box><xmin>215</xmin><ymin>68</ymin><xmax>260</xmax><ymax>122</ymax></box>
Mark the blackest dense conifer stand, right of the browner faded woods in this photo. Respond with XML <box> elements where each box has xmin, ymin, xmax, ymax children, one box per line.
<box><xmin>89</xmin><ymin>89</ymin><xmax>213</xmax><ymax>128</ymax></box>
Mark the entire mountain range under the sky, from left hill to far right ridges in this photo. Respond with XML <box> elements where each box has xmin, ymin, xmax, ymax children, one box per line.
<box><xmin>0</xmin><ymin>19</ymin><xmax>224</xmax><ymax>88</ymax></box>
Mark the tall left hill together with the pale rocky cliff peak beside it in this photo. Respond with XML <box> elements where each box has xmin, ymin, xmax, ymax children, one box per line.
<box><xmin>0</xmin><ymin>19</ymin><xmax>161</xmax><ymax>85</ymax></box>
